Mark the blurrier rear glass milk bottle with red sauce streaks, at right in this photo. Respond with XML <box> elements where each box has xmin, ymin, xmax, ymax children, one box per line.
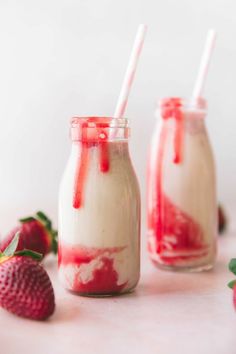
<box><xmin>147</xmin><ymin>98</ymin><xmax>217</xmax><ymax>271</ymax></box>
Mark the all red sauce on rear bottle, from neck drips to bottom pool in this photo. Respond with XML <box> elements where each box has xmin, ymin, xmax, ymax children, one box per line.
<box><xmin>148</xmin><ymin>98</ymin><xmax>207</xmax><ymax>265</ymax></box>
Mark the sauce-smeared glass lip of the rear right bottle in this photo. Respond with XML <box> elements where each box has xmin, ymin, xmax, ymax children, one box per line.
<box><xmin>158</xmin><ymin>97</ymin><xmax>207</xmax><ymax>111</ymax></box>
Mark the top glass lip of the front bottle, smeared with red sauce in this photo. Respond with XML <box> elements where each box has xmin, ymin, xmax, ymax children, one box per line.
<box><xmin>70</xmin><ymin>116</ymin><xmax>129</xmax><ymax>128</ymax></box>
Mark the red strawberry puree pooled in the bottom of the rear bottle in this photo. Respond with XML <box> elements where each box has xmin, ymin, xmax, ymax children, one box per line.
<box><xmin>148</xmin><ymin>195</ymin><xmax>208</xmax><ymax>265</ymax></box>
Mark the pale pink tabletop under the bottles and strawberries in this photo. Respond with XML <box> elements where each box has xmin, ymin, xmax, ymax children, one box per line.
<box><xmin>0</xmin><ymin>234</ymin><xmax>236</xmax><ymax>354</ymax></box>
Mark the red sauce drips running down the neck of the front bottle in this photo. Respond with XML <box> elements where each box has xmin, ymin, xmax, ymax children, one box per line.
<box><xmin>72</xmin><ymin>117</ymin><xmax>110</xmax><ymax>209</ymax></box>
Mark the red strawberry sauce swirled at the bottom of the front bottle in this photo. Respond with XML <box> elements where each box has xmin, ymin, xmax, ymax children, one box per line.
<box><xmin>58</xmin><ymin>245</ymin><xmax>127</xmax><ymax>294</ymax></box>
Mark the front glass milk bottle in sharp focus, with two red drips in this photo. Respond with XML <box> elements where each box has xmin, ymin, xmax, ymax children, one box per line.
<box><xmin>58</xmin><ymin>117</ymin><xmax>140</xmax><ymax>296</ymax></box>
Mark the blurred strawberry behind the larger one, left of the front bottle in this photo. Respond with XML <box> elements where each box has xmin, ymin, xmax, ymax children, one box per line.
<box><xmin>0</xmin><ymin>211</ymin><xmax>57</xmax><ymax>256</ymax></box>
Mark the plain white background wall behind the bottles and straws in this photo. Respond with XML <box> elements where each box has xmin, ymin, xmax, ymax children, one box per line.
<box><xmin>0</xmin><ymin>0</ymin><xmax>236</xmax><ymax>232</ymax></box>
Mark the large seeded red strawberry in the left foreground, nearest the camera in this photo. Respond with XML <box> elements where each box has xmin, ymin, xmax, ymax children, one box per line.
<box><xmin>0</xmin><ymin>233</ymin><xmax>55</xmax><ymax>320</ymax></box>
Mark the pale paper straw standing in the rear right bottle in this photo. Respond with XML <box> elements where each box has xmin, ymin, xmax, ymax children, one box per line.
<box><xmin>191</xmin><ymin>29</ymin><xmax>216</xmax><ymax>102</ymax></box>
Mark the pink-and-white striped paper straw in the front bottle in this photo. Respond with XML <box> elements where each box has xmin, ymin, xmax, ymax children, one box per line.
<box><xmin>114</xmin><ymin>24</ymin><xmax>147</xmax><ymax>118</ymax></box>
